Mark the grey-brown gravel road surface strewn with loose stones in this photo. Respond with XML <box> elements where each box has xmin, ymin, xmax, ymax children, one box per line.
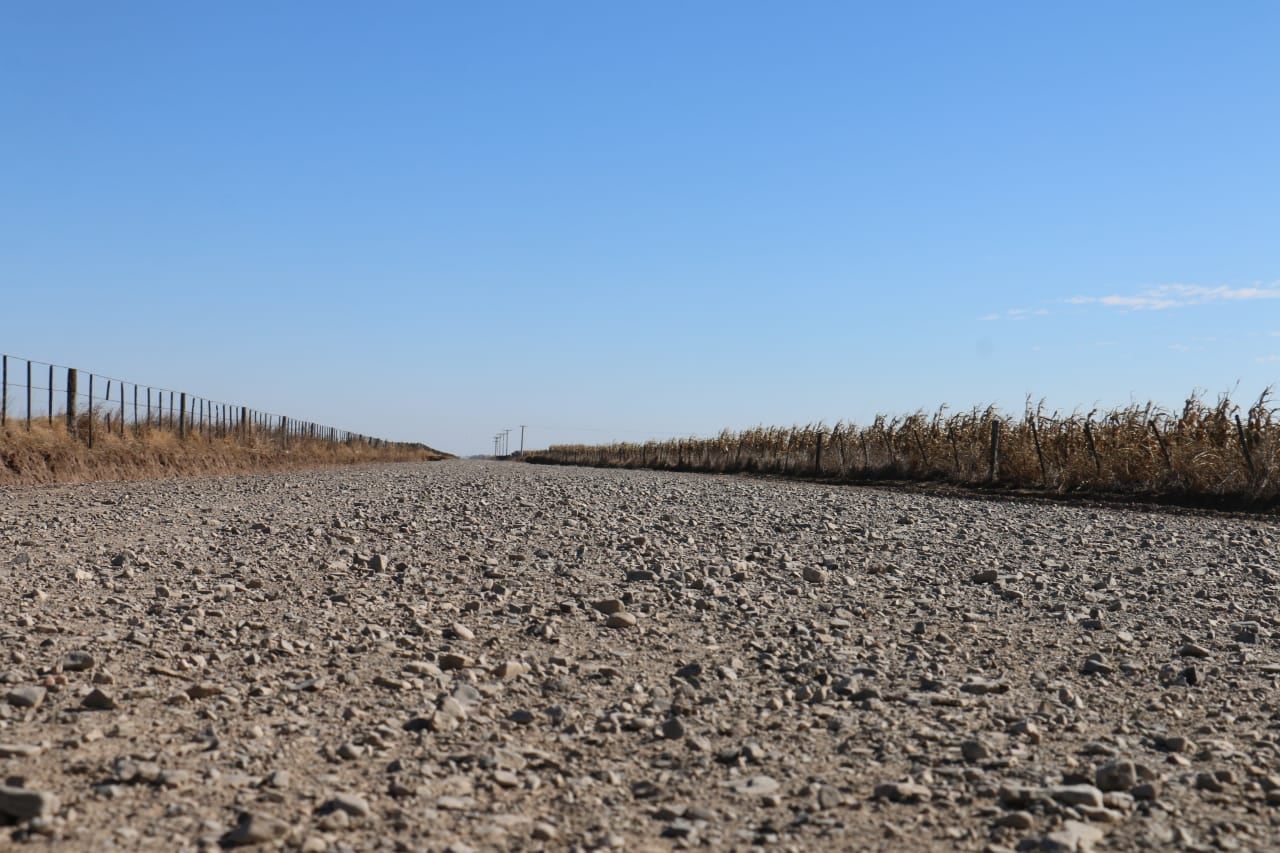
<box><xmin>0</xmin><ymin>461</ymin><xmax>1280</xmax><ymax>852</ymax></box>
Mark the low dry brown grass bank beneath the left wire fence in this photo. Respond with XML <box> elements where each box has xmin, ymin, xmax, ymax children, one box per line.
<box><xmin>0</xmin><ymin>415</ymin><xmax>447</xmax><ymax>485</ymax></box>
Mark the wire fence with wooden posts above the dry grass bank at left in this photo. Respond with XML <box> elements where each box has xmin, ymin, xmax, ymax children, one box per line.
<box><xmin>0</xmin><ymin>353</ymin><xmax>397</xmax><ymax>447</ymax></box>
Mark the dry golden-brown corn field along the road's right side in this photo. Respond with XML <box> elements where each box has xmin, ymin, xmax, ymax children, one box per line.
<box><xmin>525</xmin><ymin>388</ymin><xmax>1280</xmax><ymax>503</ymax></box>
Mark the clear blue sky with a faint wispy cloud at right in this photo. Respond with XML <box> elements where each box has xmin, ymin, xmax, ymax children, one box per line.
<box><xmin>0</xmin><ymin>0</ymin><xmax>1280</xmax><ymax>455</ymax></box>
